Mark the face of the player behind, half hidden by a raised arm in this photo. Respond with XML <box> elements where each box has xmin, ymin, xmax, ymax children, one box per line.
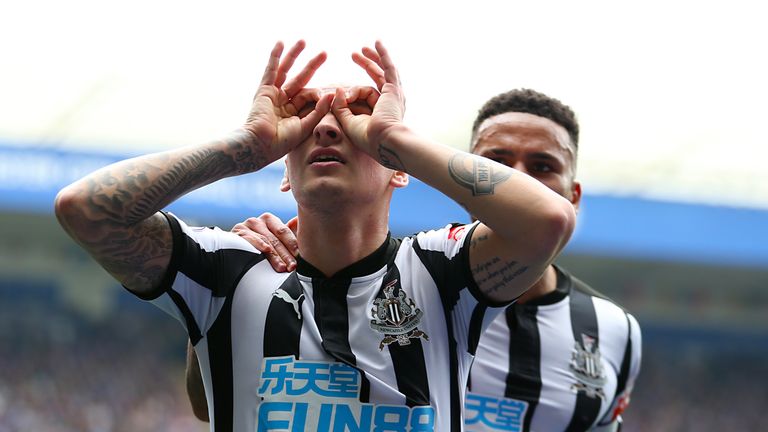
<box><xmin>472</xmin><ymin>112</ymin><xmax>581</xmax><ymax>208</ymax></box>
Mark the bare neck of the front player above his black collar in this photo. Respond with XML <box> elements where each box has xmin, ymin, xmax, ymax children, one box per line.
<box><xmin>296</xmin><ymin>202</ymin><xmax>389</xmax><ymax>276</ymax></box>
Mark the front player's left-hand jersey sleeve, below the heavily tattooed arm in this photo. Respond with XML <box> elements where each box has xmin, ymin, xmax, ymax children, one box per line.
<box><xmin>135</xmin><ymin>213</ymin><xmax>264</xmax><ymax>344</ymax></box>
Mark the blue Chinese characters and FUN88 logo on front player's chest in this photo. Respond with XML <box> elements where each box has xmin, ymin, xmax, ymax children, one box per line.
<box><xmin>256</xmin><ymin>356</ymin><xmax>435</xmax><ymax>432</ymax></box>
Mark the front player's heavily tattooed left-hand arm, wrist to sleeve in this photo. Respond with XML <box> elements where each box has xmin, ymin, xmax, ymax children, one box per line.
<box><xmin>55</xmin><ymin>128</ymin><xmax>269</xmax><ymax>291</ymax></box>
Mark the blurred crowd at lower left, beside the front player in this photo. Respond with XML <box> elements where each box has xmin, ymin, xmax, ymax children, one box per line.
<box><xmin>0</xmin><ymin>286</ymin><xmax>207</xmax><ymax>432</ymax></box>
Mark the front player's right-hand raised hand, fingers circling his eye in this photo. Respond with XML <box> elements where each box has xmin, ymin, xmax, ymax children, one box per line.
<box><xmin>332</xmin><ymin>41</ymin><xmax>412</xmax><ymax>171</ymax></box>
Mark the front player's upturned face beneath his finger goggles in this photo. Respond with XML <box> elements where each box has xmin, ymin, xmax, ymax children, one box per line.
<box><xmin>284</xmin><ymin>89</ymin><xmax>396</xmax><ymax>207</ymax></box>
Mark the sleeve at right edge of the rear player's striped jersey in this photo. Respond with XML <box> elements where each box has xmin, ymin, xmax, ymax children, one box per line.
<box><xmin>598</xmin><ymin>313</ymin><xmax>642</xmax><ymax>426</ymax></box>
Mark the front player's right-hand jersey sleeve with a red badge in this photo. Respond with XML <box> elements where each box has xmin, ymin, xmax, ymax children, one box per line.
<box><xmin>414</xmin><ymin>222</ymin><xmax>507</xmax><ymax>355</ymax></box>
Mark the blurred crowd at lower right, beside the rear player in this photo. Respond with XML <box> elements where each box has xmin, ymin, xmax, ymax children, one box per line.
<box><xmin>622</xmin><ymin>334</ymin><xmax>768</xmax><ymax>432</ymax></box>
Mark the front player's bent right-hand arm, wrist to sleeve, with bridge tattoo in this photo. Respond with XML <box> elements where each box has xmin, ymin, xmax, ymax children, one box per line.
<box><xmin>379</xmin><ymin>129</ymin><xmax>575</xmax><ymax>301</ymax></box>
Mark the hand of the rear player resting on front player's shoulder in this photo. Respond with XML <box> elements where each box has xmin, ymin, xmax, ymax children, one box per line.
<box><xmin>232</xmin><ymin>213</ymin><xmax>299</xmax><ymax>273</ymax></box>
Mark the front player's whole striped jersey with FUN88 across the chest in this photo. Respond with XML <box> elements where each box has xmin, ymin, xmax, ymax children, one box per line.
<box><xmin>140</xmin><ymin>214</ymin><xmax>504</xmax><ymax>432</ymax></box>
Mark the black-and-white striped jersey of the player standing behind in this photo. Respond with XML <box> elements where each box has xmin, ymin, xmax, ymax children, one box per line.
<box><xmin>464</xmin><ymin>267</ymin><xmax>641</xmax><ymax>432</ymax></box>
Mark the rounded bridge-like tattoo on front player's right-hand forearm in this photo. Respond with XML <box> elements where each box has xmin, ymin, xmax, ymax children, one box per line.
<box><xmin>448</xmin><ymin>153</ymin><xmax>512</xmax><ymax>196</ymax></box>
